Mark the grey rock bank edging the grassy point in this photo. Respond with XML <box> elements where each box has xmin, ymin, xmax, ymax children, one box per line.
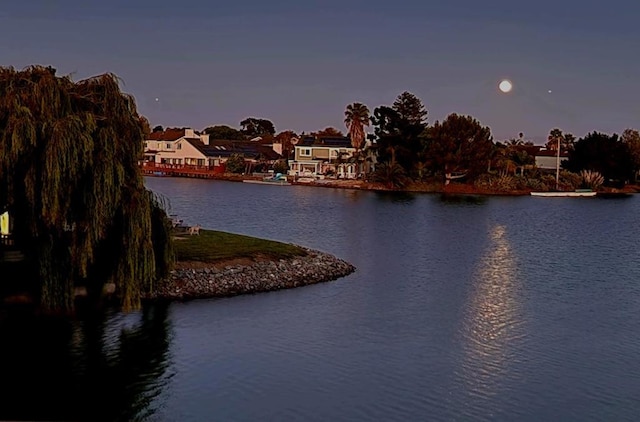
<box><xmin>150</xmin><ymin>248</ymin><xmax>356</xmax><ymax>300</ymax></box>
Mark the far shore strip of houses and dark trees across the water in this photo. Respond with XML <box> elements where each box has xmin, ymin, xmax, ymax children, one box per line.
<box><xmin>146</xmin><ymin>91</ymin><xmax>640</xmax><ymax>197</ymax></box>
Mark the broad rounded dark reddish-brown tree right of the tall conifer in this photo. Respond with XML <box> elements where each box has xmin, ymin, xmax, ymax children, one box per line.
<box><xmin>424</xmin><ymin>113</ymin><xmax>493</xmax><ymax>176</ymax></box>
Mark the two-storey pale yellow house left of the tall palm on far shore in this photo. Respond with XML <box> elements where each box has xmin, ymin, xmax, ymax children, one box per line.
<box><xmin>289</xmin><ymin>136</ymin><xmax>358</xmax><ymax>179</ymax></box>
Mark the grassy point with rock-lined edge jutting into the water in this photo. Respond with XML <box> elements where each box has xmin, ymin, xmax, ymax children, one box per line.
<box><xmin>0</xmin><ymin>227</ymin><xmax>356</xmax><ymax>308</ymax></box>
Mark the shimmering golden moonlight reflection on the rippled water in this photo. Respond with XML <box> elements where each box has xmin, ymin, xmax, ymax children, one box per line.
<box><xmin>461</xmin><ymin>225</ymin><xmax>521</xmax><ymax>404</ymax></box>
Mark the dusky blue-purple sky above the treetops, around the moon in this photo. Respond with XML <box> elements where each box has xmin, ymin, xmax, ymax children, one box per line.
<box><xmin>0</xmin><ymin>0</ymin><xmax>640</xmax><ymax>143</ymax></box>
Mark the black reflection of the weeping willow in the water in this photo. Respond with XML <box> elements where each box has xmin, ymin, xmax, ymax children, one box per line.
<box><xmin>0</xmin><ymin>304</ymin><xmax>169</xmax><ymax>421</ymax></box>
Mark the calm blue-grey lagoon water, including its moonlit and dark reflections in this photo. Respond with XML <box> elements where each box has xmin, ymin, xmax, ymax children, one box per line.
<box><xmin>0</xmin><ymin>178</ymin><xmax>640</xmax><ymax>421</ymax></box>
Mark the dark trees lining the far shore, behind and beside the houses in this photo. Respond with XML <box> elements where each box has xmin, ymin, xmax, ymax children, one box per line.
<box><xmin>174</xmin><ymin>91</ymin><xmax>640</xmax><ymax>190</ymax></box>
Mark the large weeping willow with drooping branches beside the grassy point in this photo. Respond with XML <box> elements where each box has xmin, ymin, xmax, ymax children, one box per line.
<box><xmin>0</xmin><ymin>66</ymin><xmax>172</xmax><ymax>310</ymax></box>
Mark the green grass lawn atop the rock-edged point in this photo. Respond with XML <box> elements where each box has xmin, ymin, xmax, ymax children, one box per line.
<box><xmin>173</xmin><ymin>229</ymin><xmax>307</xmax><ymax>263</ymax></box>
